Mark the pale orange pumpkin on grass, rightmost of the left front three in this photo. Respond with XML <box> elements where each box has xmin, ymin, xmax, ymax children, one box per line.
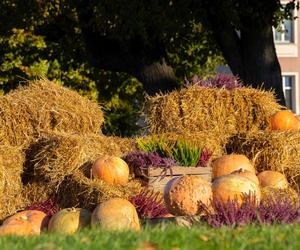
<box><xmin>91</xmin><ymin>198</ymin><xmax>141</xmax><ymax>231</ymax></box>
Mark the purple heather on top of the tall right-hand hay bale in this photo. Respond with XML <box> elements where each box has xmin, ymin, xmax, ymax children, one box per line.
<box><xmin>184</xmin><ymin>74</ymin><xmax>242</xmax><ymax>90</ymax></box>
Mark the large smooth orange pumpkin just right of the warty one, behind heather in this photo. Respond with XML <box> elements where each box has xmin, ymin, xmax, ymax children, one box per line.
<box><xmin>212</xmin><ymin>174</ymin><xmax>261</xmax><ymax>205</ymax></box>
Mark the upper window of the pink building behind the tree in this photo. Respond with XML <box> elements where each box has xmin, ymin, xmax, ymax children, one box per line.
<box><xmin>274</xmin><ymin>20</ymin><xmax>294</xmax><ymax>43</ymax></box>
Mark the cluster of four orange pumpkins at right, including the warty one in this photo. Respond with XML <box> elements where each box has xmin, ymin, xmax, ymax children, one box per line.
<box><xmin>164</xmin><ymin>154</ymin><xmax>296</xmax><ymax>215</ymax></box>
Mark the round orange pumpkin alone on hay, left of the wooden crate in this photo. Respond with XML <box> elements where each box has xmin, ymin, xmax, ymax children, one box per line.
<box><xmin>92</xmin><ymin>155</ymin><xmax>129</xmax><ymax>184</ymax></box>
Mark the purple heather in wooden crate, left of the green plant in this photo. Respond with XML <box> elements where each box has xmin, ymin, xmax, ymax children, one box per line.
<box><xmin>123</xmin><ymin>151</ymin><xmax>178</xmax><ymax>177</ymax></box>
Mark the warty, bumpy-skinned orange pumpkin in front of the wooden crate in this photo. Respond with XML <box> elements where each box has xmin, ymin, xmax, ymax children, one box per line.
<box><xmin>164</xmin><ymin>176</ymin><xmax>212</xmax><ymax>215</ymax></box>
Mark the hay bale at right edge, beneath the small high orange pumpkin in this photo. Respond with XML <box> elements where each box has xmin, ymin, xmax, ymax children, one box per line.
<box><xmin>226</xmin><ymin>131</ymin><xmax>300</xmax><ymax>188</ymax></box>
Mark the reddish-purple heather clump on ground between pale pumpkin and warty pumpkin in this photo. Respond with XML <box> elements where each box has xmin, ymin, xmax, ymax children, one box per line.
<box><xmin>129</xmin><ymin>189</ymin><xmax>168</xmax><ymax>218</ymax></box>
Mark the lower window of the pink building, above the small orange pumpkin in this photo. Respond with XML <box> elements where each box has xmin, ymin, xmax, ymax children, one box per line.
<box><xmin>282</xmin><ymin>75</ymin><xmax>296</xmax><ymax>113</ymax></box>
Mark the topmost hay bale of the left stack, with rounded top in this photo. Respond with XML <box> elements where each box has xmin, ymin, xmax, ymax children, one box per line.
<box><xmin>0</xmin><ymin>79</ymin><xmax>104</xmax><ymax>145</ymax></box>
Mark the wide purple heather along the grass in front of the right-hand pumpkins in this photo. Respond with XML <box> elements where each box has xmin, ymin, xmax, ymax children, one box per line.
<box><xmin>202</xmin><ymin>191</ymin><xmax>300</xmax><ymax>227</ymax></box>
